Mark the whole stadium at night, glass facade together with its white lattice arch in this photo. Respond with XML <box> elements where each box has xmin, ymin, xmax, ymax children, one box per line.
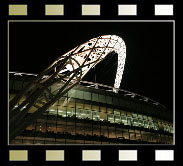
<box><xmin>9</xmin><ymin>35</ymin><xmax>174</xmax><ymax>144</ymax></box>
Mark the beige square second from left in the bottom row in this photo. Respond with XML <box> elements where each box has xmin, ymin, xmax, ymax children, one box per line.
<box><xmin>46</xmin><ymin>150</ymin><xmax>64</xmax><ymax>161</ymax></box>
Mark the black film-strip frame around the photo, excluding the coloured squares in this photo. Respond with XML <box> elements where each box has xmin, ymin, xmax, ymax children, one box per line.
<box><xmin>0</xmin><ymin>0</ymin><xmax>180</xmax><ymax>166</ymax></box>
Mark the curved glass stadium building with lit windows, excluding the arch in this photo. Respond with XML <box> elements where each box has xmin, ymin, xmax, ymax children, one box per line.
<box><xmin>9</xmin><ymin>72</ymin><xmax>174</xmax><ymax>144</ymax></box>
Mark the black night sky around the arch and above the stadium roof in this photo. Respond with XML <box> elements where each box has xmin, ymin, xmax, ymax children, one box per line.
<box><xmin>9</xmin><ymin>22</ymin><xmax>173</xmax><ymax>109</ymax></box>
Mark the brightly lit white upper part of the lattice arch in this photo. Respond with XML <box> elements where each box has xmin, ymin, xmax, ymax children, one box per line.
<box><xmin>58</xmin><ymin>35</ymin><xmax>126</xmax><ymax>91</ymax></box>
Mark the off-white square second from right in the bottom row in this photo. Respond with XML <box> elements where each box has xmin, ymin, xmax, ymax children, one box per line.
<box><xmin>119</xmin><ymin>150</ymin><xmax>137</xmax><ymax>161</ymax></box>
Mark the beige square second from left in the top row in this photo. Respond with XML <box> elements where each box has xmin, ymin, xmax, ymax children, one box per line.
<box><xmin>45</xmin><ymin>5</ymin><xmax>64</xmax><ymax>16</ymax></box>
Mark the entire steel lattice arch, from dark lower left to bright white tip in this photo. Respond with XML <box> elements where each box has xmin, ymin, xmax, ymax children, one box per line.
<box><xmin>9</xmin><ymin>35</ymin><xmax>126</xmax><ymax>140</ymax></box>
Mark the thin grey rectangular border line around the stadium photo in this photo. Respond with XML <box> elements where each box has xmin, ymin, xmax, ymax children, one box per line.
<box><xmin>6</xmin><ymin>19</ymin><xmax>176</xmax><ymax>147</ymax></box>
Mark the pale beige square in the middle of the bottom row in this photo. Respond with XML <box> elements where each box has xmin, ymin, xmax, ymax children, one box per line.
<box><xmin>82</xmin><ymin>150</ymin><xmax>101</xmax><ymax>161</ymax></box>
